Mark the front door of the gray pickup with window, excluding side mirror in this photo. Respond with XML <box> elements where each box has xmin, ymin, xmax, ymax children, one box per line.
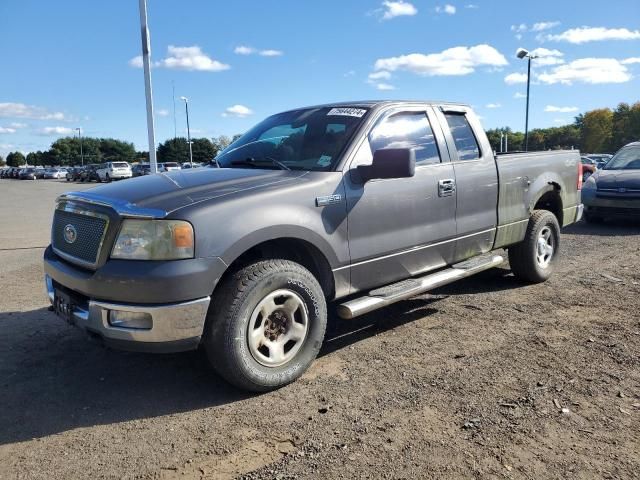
<box><xmin>345</xmin><ymin>107</ymin><xmax>456</xmax><ymax>292</ymax></box>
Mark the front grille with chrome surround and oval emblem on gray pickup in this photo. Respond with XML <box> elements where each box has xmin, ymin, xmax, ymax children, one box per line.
<box><xmin>51</xmin><ymin>209</ymin><xmax>109</xmax><ymax>267</ymax></box>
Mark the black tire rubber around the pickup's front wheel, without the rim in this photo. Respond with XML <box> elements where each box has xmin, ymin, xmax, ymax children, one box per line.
<box><xmin>203</xmin><ymin>260</ymin><xmax>327</xmax><ymax>392</ymax></box>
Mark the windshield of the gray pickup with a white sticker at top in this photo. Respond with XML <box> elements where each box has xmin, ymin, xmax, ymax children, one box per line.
<box><xmin>216</xmin><ymin>107</ymin><xmax>368</xmax><ymax>171</ymax></box>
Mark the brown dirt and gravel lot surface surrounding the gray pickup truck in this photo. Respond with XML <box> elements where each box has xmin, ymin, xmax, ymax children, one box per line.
<box><xmin>0</xmin><ymin>180</ymin><xmax>640</xmax><ymax>479</ymax></box>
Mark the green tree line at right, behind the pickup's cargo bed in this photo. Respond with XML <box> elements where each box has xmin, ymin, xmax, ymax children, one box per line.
<box><xmin>487</xmin><ymin>102</ymin><xmax>640</xmax><ymax>153</ymax></box>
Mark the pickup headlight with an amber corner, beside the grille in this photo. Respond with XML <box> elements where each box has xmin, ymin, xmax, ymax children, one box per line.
<box><xmin>111</xmin><ymin>219</ymin><xmax>194</xmax><ymax>260</ymax></box>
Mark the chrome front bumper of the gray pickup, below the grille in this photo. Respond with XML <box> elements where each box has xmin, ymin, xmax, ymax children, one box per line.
<box><xmin>45</xmin><ymin>275</ymin><xmax>211</xmax><ymax>353</ymax></box>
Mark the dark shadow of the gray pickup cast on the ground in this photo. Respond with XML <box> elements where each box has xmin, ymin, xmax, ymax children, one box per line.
<box><xmin>0</xmin><ymin>272</ymin><xmax>517</xmax><ymax>445</ymax></box>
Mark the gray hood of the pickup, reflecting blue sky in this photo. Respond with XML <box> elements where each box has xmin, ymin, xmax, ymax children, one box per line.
<box><xmin>64</xmin><ymin>168</ymin><xmax>306</xmax><ymax>217</ymax></box>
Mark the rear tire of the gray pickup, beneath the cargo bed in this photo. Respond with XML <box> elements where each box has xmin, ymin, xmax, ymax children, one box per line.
<box><xmin>509</xmin><ymin>210</ymin><xmax>560</xmax><ymax>283</ymax></box>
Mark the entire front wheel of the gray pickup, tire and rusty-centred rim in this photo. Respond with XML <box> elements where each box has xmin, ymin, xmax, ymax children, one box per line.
<box><xmin>203</xmin><ymin>260</ymin><xmax>327</xmax><ymax>392</ymax></box>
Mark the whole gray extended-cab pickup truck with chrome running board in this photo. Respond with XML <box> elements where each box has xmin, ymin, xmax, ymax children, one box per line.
<box><xmin>44</xmin><ymin>101</ymin><xmax>582</xmax><ymax>391</ymax></box>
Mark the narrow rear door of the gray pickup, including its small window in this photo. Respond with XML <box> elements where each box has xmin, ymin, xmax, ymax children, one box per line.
<box><xmin>434</xmin><ymin>105</ymin><xmax>498</xmax><ymax>261</ymax></box>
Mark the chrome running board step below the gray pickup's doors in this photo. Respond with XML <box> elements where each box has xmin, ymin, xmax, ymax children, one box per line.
<box><xmin>338</xmin><ymin>253</ymin><xmax>505</xmax><ymax>320</ymax></box>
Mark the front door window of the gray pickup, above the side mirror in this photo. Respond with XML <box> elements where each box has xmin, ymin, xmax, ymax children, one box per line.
<box><xmin>369</xmin><ymin>112</ymin><xmax>440</xmax><ymax>165</ymax></box>
